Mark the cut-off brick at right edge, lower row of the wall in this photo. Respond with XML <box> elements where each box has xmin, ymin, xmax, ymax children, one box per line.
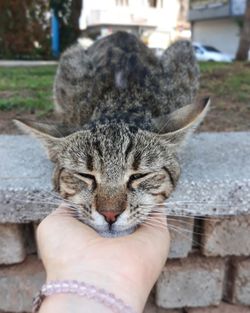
<box><xmin>230</xmin><ymin>258</ymin><xmax>250</xmax><ymax>305</ymax></box>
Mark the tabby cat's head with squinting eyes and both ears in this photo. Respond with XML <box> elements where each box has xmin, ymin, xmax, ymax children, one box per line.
<box><xmin>16</xmin><ymin>99</ymin><xmax>209</xmax><ymax>235</ymax></box>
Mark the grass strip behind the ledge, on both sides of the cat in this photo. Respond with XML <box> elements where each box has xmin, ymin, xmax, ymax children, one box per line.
<box><xmin>0</xmin><ymin>62</ymin><xmax>250</xmax><ymax>119</ymax></box>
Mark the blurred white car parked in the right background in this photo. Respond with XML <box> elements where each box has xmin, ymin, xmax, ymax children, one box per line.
<box><xmin>193</xmin><ymin>43</ymin><xmax>233</xmax><ymax>62</ymax></box>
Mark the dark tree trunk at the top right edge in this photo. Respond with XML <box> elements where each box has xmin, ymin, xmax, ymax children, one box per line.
<box><xmin>236</xmin><ymin>0</ymin><xmax>250</xmax><ymax>61</ymax></box>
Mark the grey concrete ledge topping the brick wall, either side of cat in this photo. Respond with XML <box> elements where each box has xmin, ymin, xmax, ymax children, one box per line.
<box><xmin>0</xmin><ymin>132</ymin><xmax>250</xmax><ymax>223</ymax></box>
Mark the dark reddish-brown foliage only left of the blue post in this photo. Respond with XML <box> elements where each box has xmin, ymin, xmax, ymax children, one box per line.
<box><xmin>0</xmin><ymin>0</ymin><xmax>50</xmax><ymax>59</ymax></box>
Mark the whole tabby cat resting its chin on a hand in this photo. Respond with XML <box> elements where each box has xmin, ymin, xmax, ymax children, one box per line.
<box><xmin>16</xmin><ymin>32</ymin><xmax>210</xmax><ymax>236</ymax></box>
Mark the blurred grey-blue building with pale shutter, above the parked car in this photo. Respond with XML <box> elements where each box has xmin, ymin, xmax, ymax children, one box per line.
<box><xmin>189</xmin><ymin>0</ymin><xmax>246</xmax><ymax>56</ymax></box>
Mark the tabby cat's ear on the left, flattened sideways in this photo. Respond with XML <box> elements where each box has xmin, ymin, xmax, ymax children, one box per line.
<box><xmin>13</xmin><ymin>119</ymin><xmax>63</xmax><ymax>162</ymax></box>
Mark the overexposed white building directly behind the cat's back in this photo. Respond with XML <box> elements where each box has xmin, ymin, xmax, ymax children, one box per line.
<box><xmin>80</xmin><ymin>0</ymin><xmax>191</xmax><ymax>49</ymax></box>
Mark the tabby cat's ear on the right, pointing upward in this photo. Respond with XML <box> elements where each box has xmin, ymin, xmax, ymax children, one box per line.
<box><xmin>154</xmin><ymin>98</ymin><xmax>210</xmax><ymax>146</ymax></box>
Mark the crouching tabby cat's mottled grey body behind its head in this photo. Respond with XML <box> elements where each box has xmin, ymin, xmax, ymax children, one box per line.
<box><xmin>54</xmin><ymin>32</ymin><xmax>199</xmax><ymax>130</ymax></box>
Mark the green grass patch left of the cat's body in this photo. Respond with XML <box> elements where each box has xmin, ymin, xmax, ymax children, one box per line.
<box><xmin>0</xmin><ymin>66</ymin><xmax>56</xmax><ymax>113</ymax></box>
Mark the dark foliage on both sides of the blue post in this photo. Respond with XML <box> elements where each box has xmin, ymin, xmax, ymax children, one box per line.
<box><xmin>0</xmin><ymin>0</ymin><xmax>82</xmax><ymax>59</ymax></box>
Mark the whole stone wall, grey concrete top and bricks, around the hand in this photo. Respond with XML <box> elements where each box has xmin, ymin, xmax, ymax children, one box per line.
<box><xmin>0</xmin><ymin>133</ymin><xmax>250</xmax><ymax>313</ymax></box>
